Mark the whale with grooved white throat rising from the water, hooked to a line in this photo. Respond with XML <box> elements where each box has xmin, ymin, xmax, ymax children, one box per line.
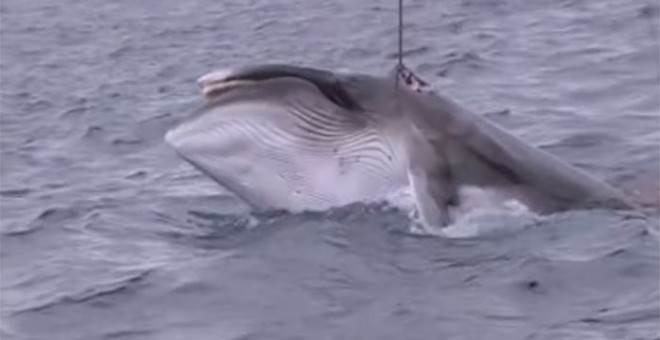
<box><xmin>165</xmin><ymin>64</ymin><xmax>636</xmax><ymax>233</ymax></box>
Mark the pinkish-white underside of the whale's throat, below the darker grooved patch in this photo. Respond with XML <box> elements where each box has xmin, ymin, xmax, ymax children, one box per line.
<box><xmin>166</xmin><ymin>102</ymin><xmax>408</xmax><ymax>212</ymax></box>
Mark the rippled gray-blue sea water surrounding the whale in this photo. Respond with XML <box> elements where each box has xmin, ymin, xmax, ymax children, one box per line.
<box><xmin>0</xmin><ymin>0</ymin><xmax>660</xmax><ymax>340</ymax></box>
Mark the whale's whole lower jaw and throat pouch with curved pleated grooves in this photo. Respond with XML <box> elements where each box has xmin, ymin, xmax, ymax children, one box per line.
<box><xmin>166</xmin><ymin>78</ymin><xmax>406</xmax><ymax>211</ymax></box>
